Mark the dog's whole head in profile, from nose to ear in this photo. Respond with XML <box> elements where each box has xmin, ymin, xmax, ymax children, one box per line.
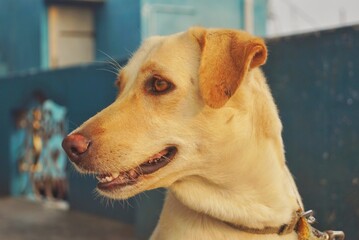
<box><xmin>63</xmin><ymin>28</ymin><xmax>267</xmax><ymax>198</ymax></box>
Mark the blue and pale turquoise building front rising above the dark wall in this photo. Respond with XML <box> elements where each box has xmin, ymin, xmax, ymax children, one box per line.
<box><xmin>0</xmin><ymin>0</ymin><xmax>267</xmax><ymax>76</ymax></box>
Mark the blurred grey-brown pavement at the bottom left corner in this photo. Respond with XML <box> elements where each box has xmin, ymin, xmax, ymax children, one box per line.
<box><xmin>0</xmin><ymin>198</ymin><xmax>136</xmax><ymax>240</ymax></box>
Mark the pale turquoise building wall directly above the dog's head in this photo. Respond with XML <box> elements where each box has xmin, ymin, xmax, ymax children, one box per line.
<box><xmin>141</xmin><ymin>0</ymin><xmax>267</xmax><ymax>37</ymax></box>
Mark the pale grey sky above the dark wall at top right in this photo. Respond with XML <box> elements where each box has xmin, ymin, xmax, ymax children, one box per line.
<box><xmin>267</xmin><ymin>0</ymin><xmax>359</xmax><ymax>36</ymax></box>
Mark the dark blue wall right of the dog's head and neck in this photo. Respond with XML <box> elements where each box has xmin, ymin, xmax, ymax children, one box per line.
<box><xmin>264</xmin><ymin>26</ymin><xmax>359</xmax><ymax>239</ymax></box>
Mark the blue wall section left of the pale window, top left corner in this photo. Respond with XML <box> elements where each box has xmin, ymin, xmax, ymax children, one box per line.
<box><xmin>0</xmin><ymin>0</ymin><xmax>45</xmax><ymax>73</ymax></box>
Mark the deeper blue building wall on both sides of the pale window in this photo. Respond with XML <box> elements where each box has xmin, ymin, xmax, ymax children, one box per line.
<box><xmin>0</xmin><ymin>0</ymin><xmax>141</xmax><ymax>76</ymax></box>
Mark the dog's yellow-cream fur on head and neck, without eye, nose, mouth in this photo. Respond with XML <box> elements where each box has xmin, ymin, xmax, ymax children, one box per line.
<box><xmin>67</xmin><ymin>28</ymin><xmax>301</xmax><ymax>240</ymax></box>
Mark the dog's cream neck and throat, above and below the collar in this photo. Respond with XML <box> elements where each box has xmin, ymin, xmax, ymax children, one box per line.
<box><xmin>152</xmin><ymin>137</ymin><xmax>300</xmax><ymax>240</ymax></box>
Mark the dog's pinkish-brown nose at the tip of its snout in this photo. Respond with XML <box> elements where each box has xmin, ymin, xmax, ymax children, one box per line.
<box><xmin>62</xmin><ymin>133</ymin><xmax>91</xmax><ymax>163</ymax></box>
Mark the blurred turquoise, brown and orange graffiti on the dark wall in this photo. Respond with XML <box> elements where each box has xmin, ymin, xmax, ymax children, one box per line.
<box><xmin>11</xmin><ymin>91</ymin><xmax>67</xmax><ymax>204</ymax></box>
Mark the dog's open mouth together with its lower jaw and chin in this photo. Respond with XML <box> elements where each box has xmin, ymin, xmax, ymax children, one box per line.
<box><xmin>86</xmin><ymin>146</ymin><xmax>178</xmax><ymax>199</ymax></box>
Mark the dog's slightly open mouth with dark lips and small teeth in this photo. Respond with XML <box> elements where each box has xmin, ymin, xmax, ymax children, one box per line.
<box><xmin>96</xmin><ymin>146</ymin><xmax>178</xmax><ymax>191</ymax></box>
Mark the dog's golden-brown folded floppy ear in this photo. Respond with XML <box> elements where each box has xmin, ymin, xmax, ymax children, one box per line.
<box><xmin>189</xmin><ymin>27</ymin><xmax>267</xmax><ymax>108</ymax></box>
